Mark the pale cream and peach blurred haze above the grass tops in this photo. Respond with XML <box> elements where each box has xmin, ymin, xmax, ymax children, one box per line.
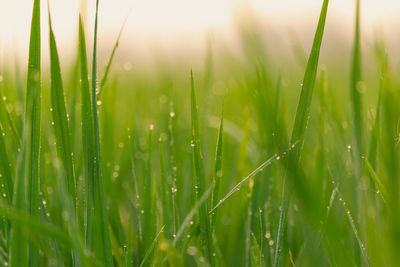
<box><xmin>0</xmin><ymin>0</ymin><xmax>400</xmax><ymax>68</ymax></box>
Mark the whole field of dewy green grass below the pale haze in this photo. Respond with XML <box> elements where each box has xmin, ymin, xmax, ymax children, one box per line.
<box><xmin>0</xmin><ymin>0</ymin><xmax>400</xmax><ymax>267</ymax></box>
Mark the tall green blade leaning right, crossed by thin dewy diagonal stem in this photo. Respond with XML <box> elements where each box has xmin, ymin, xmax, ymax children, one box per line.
<box><xmin>273</xmin><ymin>0</ymin><xmax>329</xmax><ymax>267</ymax></box>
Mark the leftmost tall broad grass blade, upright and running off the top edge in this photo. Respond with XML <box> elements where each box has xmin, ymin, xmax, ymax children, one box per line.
<box><xmin>10</xmin><ymin>0</ymin><xmax>41</xmax><ymax>266</ymax></box>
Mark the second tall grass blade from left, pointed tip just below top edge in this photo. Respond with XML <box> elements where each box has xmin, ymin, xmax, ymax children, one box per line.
<box><xmin>49</xmin><ymin>11</ymin><xmax>76</xmax><ymax>202</ymax></box>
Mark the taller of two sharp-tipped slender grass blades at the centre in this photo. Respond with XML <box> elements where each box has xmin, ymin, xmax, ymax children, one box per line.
<box><xmin>190</xmin><ymin>70</ymin><xmax>213</xmax><ymax>264</ymax></box>
